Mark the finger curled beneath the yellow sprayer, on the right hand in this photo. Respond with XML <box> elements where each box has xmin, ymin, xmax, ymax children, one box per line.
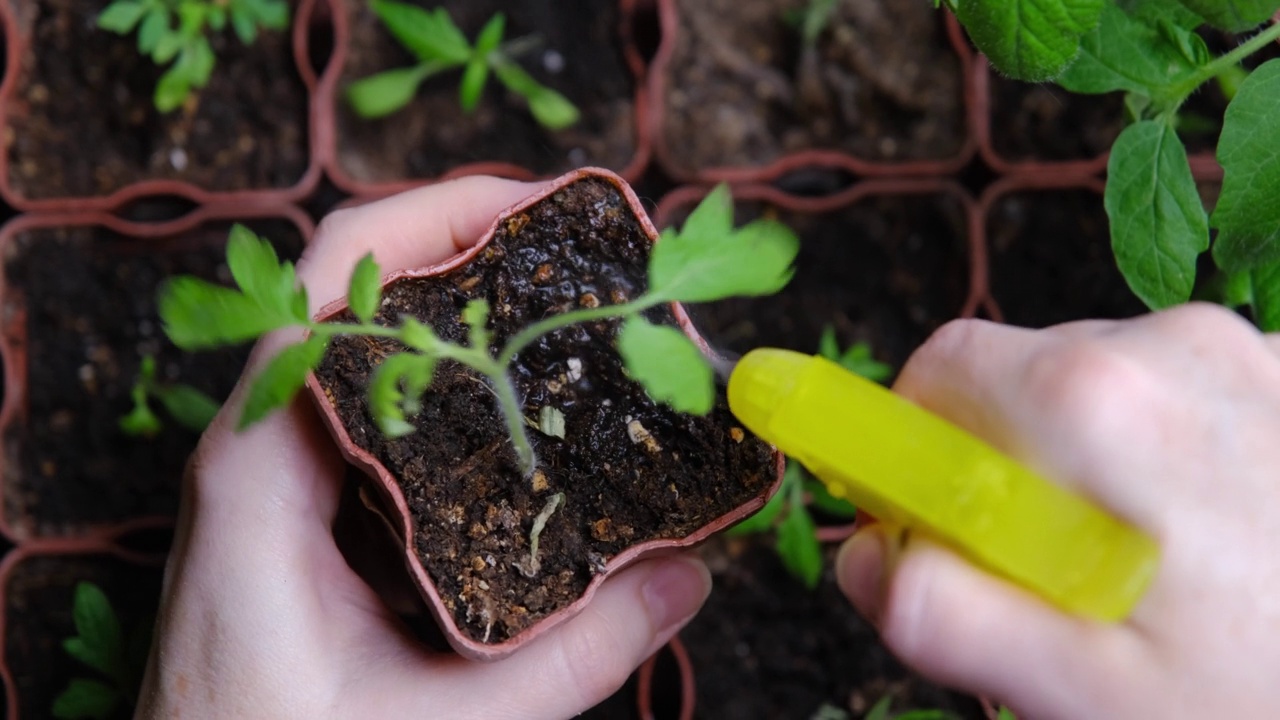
<box><xmin>836</xmin><ymin>525</ymin><xmax>1138</xmax><ymax>717</ymax></box>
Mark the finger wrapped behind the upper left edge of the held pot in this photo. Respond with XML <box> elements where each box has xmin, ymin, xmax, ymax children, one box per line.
<box><xmin>298</xmin><ymin>177</ymin><xmax>545</xmax><ymax>311</ymax></box>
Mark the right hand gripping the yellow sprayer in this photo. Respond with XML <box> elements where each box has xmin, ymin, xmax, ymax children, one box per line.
<box><xmin>837</xmin><ymin>305</ymin><xmax>1280</xmax><ymax>719</ymax></box>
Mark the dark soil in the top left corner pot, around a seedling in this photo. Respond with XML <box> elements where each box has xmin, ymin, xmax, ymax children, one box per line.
<box><xmin>4</xmin><ymin>0</ymin><xmax>308</xmax><ymax>199</ymax></box>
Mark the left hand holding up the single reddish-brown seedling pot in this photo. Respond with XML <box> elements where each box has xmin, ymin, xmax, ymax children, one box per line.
<box><xmin>137</xmin><ymin>178</ymin><xmax>710</xmax><ymax>719</ymax></box>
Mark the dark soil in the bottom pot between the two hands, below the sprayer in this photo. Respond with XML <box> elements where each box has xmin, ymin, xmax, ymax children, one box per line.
<box><xmin>680</xmin><ymin>536</ymin><xmax>984</xmax><ymax>720</ymax></box>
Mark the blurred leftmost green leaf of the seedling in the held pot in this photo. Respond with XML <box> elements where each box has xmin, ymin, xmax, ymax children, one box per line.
<box><xmin>159</xmin><ymin>275</ymin><xmax>305</xmax><ymax>350</ymax></box>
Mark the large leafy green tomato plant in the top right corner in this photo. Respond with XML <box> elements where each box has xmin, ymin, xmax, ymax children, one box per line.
<box><xmin>934</xmin><ymin>0</ymin><xmax>1280</xmax><ymax>331</ymax></box>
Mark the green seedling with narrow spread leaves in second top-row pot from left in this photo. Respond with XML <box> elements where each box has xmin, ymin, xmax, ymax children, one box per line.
<box><xmin>346</xmin><ymin>0</ymin><xmax>580</xmax><ymax>131</ymax></box>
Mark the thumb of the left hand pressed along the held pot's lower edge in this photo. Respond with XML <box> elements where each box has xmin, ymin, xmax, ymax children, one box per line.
<box><xmin>374</xmin><ymin>556</ymin><xmax>710</xmax><ymax>719</ymax></box>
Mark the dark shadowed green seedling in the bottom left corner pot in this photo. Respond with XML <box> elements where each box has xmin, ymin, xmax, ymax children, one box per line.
<box><xmin>51</xmin><ymin>583</ymin><xmax>151</xmax><ymax>720</ymax></box>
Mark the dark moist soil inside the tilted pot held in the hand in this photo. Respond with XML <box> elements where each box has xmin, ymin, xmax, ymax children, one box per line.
<box><xmin>317</xmin><ymin>178</ymin><xmax>774</xmax><ymax>642</ymax></box>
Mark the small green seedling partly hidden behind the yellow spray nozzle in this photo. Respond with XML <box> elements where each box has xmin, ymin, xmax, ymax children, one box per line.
<box><xmin>730</xmin><ymin>325</ymin><xmax>893</xmax><ymax>589</ymax></box>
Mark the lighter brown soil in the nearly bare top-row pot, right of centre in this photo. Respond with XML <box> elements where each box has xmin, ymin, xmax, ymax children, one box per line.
<box><xmin>660</xmin><ymin>0</ymin><xmax>965</xmax><ymax>172</ymax></box>
